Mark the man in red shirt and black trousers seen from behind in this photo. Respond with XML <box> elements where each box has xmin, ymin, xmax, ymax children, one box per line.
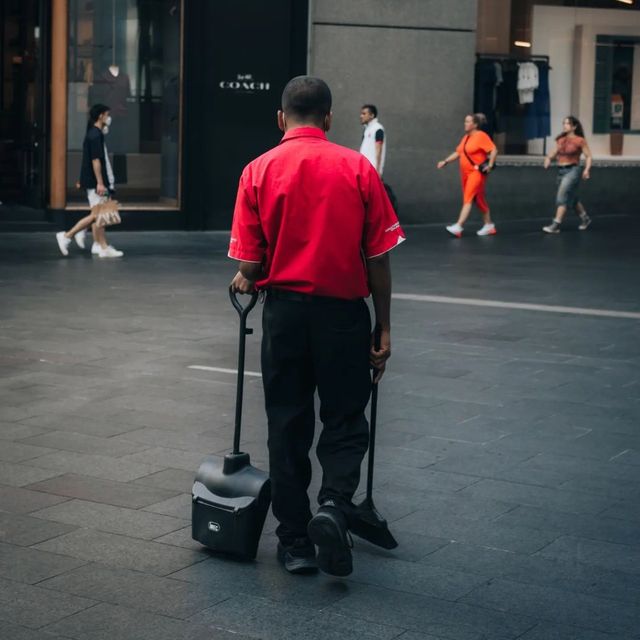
<box><xmin>229</xmin><ymin>76</ymin><xmax>404</xmax><ymax>575</ymax></box>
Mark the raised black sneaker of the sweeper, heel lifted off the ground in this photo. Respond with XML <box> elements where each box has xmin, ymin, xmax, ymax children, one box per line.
<box><xmin>307</xmin><ymin>505</ymin><xmax>353</xmax><ymax>577</ymax></box>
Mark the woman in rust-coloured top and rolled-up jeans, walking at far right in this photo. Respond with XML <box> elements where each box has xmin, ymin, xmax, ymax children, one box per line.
<box><xmin>542</xmin><ymin>116</ymin><xmax>591</xmax><ymax>233</ymax></box>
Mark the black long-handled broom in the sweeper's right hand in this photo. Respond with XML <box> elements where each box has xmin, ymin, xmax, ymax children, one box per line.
<box><xmin>349</xmin><ymin>325</ymin><xmax>398</xmax><ymax>549</ymax></box>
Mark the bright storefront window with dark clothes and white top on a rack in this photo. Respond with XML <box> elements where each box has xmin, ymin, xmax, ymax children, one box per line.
<box><xmin>474</xmin><ymin>0</ymin><xmax>640</xmax><ymax>156</ymax></box>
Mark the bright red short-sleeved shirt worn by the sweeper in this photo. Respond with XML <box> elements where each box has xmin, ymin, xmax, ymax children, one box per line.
<box><xmin>229</xmin><ymin>127</ymin><xmax>405</xmax><ymax>299</ymax></box>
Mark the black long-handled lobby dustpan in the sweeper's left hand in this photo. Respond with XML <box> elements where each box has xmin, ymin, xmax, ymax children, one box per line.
<box><xmin>191</xmin><ymin>289</ymin><xmax>271</xmax><ymax>560</ymax></box>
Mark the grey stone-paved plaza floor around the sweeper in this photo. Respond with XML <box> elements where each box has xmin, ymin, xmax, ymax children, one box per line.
<box><xmin>0</xmin><ymin>217</ymin><xmax>640</xmax><ymax>640</ymax></box>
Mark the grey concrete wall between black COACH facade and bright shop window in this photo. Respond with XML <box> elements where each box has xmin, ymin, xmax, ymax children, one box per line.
<box><xmin>309</xmin><ymin>0</ymin><xmax>477</xmax><ymax>223</ymax></box>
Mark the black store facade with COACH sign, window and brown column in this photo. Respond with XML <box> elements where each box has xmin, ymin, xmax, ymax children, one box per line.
<box><xmin>0</xmin><ymin>0</ymin><xmax>308</xmax><ymax>230</ymax></box>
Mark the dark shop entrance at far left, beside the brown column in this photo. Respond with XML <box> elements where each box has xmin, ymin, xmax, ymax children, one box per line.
<box><xmin>0</xmin><ymin>0</ymin><xmax>48</xmax><ymax>209</ymax></box>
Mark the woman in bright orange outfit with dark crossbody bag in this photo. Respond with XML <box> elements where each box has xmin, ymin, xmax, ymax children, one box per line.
<box><xmin>438</xmin><ymin>113</ymin><xmax>498</xmax><ymax>238</ymax></box>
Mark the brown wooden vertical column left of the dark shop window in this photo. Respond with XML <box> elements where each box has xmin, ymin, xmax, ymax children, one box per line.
<box><xmin>49</xmin><ymin>0</ymin><xmax>69</xmax><ymax>209</ymax></box>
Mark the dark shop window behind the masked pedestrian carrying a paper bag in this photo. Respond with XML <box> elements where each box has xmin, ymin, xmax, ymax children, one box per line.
<box><xmin>67</xmin><ymin>0</ymin><xmax>182</xmax><ymax>208</ymax></box>
